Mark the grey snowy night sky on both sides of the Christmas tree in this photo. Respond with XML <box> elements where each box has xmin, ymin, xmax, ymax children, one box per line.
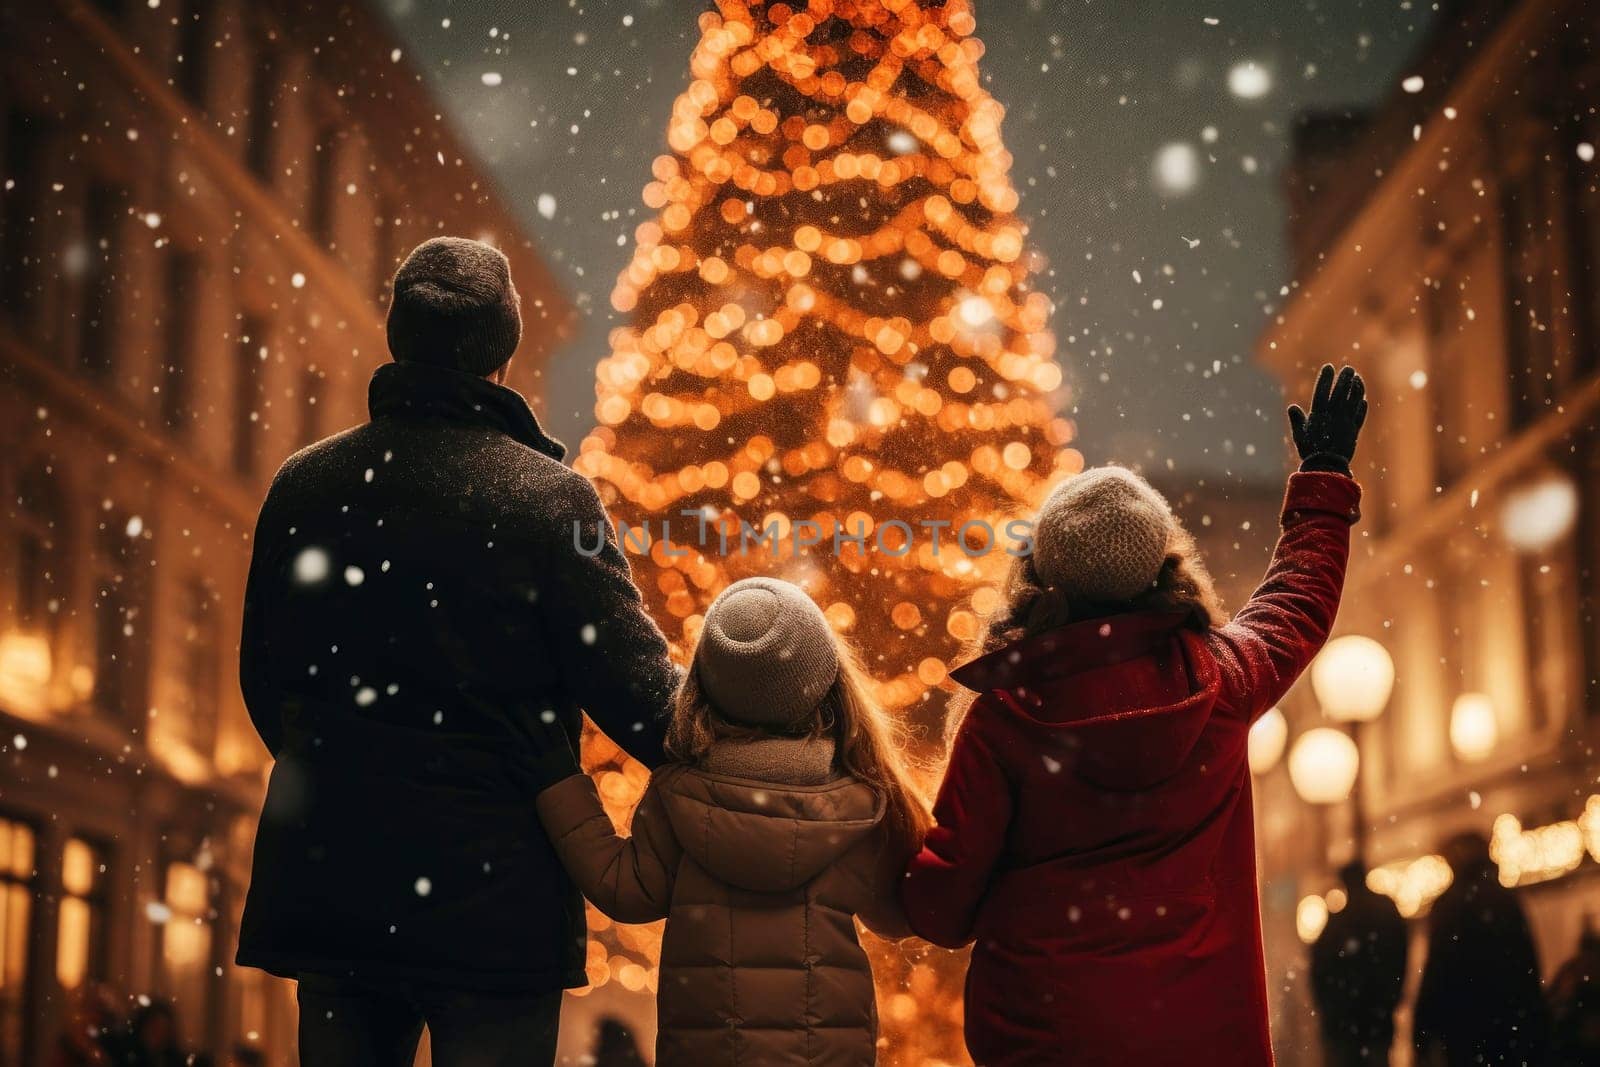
<box><xmin>379</xmin><ymin>0</ymin><xmax>1432</xmax><ymax>480</ymax></box>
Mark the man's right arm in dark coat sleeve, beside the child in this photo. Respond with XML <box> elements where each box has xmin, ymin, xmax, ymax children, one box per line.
<box><xmin>536</xmin><ymin>475</ymin><xmax>682</xmax><ymax>768</ymax></box>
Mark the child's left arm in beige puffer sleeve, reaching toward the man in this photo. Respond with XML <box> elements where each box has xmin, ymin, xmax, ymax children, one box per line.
<box><xmin>538</xmin><ymin>774</ymin><xmax>683</xmax><ymax>923</ymax></box>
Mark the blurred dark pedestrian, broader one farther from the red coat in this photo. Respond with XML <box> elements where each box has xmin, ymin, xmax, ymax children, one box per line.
<box><xmin>1414</xmin><ymin>833</ymin><xmax>1550</xmax><ymax>1067</ymax></box>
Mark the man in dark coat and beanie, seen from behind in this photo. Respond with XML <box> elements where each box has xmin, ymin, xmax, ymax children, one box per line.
<box><xmin>238</xmin><ymin>238</ymin><xmax>678</xmax><ymax>1067</ymax></box>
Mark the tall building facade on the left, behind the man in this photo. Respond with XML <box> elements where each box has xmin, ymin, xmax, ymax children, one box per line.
<box><xmin>0</xmin><ymin>0</ymin><xmax>570</xmax><ymax>1064</ymax></box>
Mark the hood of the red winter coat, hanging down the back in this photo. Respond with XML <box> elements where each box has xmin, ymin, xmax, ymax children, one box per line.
<box><xmin>950</xmin><ymin>613</ymin><xmax>1221</xmax><ymax>790</ymax></box>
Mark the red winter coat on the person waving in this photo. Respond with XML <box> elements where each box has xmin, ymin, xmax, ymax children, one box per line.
<box><xmin>902</xmin><ymin>474</ymin><xmax>1360</xmax><ymax>1067</ymax></box>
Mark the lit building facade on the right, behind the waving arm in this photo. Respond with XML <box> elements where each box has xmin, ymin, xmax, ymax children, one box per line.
<box><xmin>1258</xmin><ymin>0</ymin><xmax>1600</xmax><ymax>1062</ymax></box>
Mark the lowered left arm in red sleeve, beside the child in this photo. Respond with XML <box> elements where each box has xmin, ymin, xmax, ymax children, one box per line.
<box><xmin>901</xmin><ymin>705</ymin><xmax>1013</xmax><ymax>949</ymax></box>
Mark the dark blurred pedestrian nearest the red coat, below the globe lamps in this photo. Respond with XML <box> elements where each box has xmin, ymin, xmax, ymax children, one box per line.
<box><xmin>1310</xmin><ymin>861</ymin><xmax>1406</xmax><ymax>1067</ymax></box>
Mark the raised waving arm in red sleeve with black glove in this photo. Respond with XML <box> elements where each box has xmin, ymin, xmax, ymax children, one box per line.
<box><xmin>1211</xmin><ymin>366</ymin><xmax>1366</xmax><ymax>720</ymax></box>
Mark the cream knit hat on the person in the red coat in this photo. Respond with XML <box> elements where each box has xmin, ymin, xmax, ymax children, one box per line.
<box><xmin>1034</xmin><ymin>467</ymin><xmax>1176</xmax><ymax>603</ymax></box>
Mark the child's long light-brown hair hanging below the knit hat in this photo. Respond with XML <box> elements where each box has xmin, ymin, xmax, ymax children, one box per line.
<box><xmin>666</xmin><ymin>637</ymin><xmax>933</xmax><ymax>849</ymax></box>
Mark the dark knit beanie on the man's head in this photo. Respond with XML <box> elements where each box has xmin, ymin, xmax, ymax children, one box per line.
<box><xmin>387</xmin><ymin>237</ymin><xmax>522</xmax><ymax>378</ymax></box>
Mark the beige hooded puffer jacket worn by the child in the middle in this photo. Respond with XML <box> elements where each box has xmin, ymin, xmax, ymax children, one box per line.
<box><xmin>539</xmin><ymin>741</ymin><xmax>910</xmax><ymax>1067</ymax></box>
